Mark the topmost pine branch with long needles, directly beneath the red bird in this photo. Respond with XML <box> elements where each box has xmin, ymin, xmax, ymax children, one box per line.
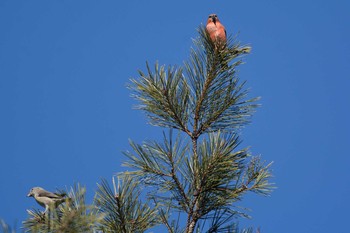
<box><xmin>185</xmin><ymin>28</ymin><xmax>257</xmax><ymax>137</ymax></box>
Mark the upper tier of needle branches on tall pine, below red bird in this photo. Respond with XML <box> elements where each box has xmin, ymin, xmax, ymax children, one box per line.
<box><xmin>129</xmin><ymin>28</ymin><xmax>257</xmax><ymax>137</ymax></box>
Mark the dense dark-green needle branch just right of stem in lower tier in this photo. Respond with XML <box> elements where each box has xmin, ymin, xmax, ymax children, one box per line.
<box><xmin>191</xmin><ymin>134</ymin><xmax>247</xmax><ymax>217</ymax></box>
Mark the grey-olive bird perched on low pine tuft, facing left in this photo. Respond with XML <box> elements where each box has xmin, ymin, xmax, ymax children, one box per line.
<box><xmin>27</xmin><ymin>187</ymin><xmax>67</xmax><ymax>213</ymax></box>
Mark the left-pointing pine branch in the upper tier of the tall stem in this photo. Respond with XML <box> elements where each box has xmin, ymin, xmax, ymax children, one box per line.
<box><xmin>129</xmin><ymin>63</ymin><xmax>190</xmax><ymax>135</ymax></box>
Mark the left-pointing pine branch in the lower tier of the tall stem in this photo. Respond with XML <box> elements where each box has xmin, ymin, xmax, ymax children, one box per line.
<box><xmin>124</xmin><ymin>132</ymin><xmax>193</xmax><ymax>212</ymax></box>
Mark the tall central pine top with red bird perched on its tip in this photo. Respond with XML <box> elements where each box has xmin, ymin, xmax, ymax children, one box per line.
<box><xmin>116</xmin><ymin>27</ymin><xmax>271</xmax><ymax>233</ymax></box>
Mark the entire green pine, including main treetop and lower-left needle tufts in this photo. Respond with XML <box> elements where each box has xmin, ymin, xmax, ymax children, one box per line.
<box><xmin>18</xmin><ymin>27</ymin><xmax>272</xmax><ymax>233</ymax></box>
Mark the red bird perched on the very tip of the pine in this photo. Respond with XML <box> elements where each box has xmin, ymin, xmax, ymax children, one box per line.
<box><xmin>206</xmin><ymin>14</ymin><xmax>226</xmax><ymax>44</ymax></box>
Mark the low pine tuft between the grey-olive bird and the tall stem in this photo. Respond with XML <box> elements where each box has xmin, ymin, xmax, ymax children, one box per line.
<box><xmin>95</xmin><ymin>176</ymin><xmax>159</xmax><ymax>233</ymax></box>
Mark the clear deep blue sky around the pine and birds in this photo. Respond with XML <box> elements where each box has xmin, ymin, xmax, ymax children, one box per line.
<box><xmin>0</xmin><ymin>0</ymin><xmax>350</xmax><ymax>233</ymax></box>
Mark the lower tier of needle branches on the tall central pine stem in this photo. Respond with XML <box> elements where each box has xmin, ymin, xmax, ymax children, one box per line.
<box><xmin>125</xmin><ymin>133</ymin><xmax>271</xmax><ymax>231</ymax></box>
